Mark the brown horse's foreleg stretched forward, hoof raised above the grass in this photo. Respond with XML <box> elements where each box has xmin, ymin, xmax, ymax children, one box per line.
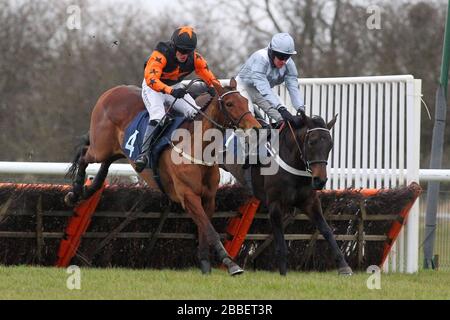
<box><xmin>184</xmin><ymin>194</ymin><xmax>244</xmax><ymax>275</ymax></box>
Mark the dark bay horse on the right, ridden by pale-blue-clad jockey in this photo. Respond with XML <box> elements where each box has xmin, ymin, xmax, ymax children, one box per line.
<box><xmin>222</xmin><ymin>113</ymin><xmax>352</xmax><ymax>275</ymax></box>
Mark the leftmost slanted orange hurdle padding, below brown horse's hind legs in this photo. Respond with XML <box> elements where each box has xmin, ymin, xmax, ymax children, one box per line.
<box><xmin>56</xmin><ymin>179</ymin><xmax>106</xmax><ymax>267</ymax></box>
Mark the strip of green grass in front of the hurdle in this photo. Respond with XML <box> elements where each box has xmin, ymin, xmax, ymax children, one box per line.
<box><xmin>0</xmin><ymin>266</ymin><xmax>450</xmax><ymax>299</ymax></box>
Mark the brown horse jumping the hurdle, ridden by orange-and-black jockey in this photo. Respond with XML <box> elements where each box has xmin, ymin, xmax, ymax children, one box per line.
<box><xmin>65</xmin><ymin>79</ymin><xmax>261</xmax><ymax>275</ymax></box>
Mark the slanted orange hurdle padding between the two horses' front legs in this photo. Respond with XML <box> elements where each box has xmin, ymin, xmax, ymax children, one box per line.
<box><xmin>224</xmin><ymin>197</ymin><xmax>260</xmax><ymax>259</ymax></box>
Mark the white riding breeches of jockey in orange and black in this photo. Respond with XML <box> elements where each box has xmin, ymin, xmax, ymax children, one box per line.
<box><xmin>142</xmin><ymin>79</ymin><xmax>200</xmax><ymax>121</ymax></box>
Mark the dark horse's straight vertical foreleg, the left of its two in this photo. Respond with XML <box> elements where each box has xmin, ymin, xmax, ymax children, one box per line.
<box><xmin>269</xmin><ymin>202</ymin><xmax>287</xmax><ymax>276</ymax></box>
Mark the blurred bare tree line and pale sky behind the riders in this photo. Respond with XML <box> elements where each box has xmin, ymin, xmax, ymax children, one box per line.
<box><xmin>0</xmin><ymin>0</ymin><xmax>450</xmax><ymax>167</ymax></box>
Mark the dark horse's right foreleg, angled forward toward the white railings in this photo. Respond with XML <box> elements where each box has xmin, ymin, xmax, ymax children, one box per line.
<box><xmin>307</xmin><ymin>199</ymin><xmax>352</xmax><ymax>275</ymax></box>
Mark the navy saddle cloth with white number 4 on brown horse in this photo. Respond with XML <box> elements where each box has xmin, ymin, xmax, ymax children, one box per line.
<box><xmin>122</xmin><ymin>110</ymin><xmax>186</xmax><ymax>192</ymax></box>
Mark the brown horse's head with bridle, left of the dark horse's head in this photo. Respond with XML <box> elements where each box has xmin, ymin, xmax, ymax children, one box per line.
<box><xmin>213</xmin><ymin>78</ymin><xmax>261</xmax><ymax>130</ymax></box>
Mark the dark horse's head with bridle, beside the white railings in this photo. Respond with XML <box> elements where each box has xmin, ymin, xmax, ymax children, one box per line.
<box><xmin>290</xmin><ymin>113</ymin><xmax>337</xmax><ymax>190</ymax></box>
